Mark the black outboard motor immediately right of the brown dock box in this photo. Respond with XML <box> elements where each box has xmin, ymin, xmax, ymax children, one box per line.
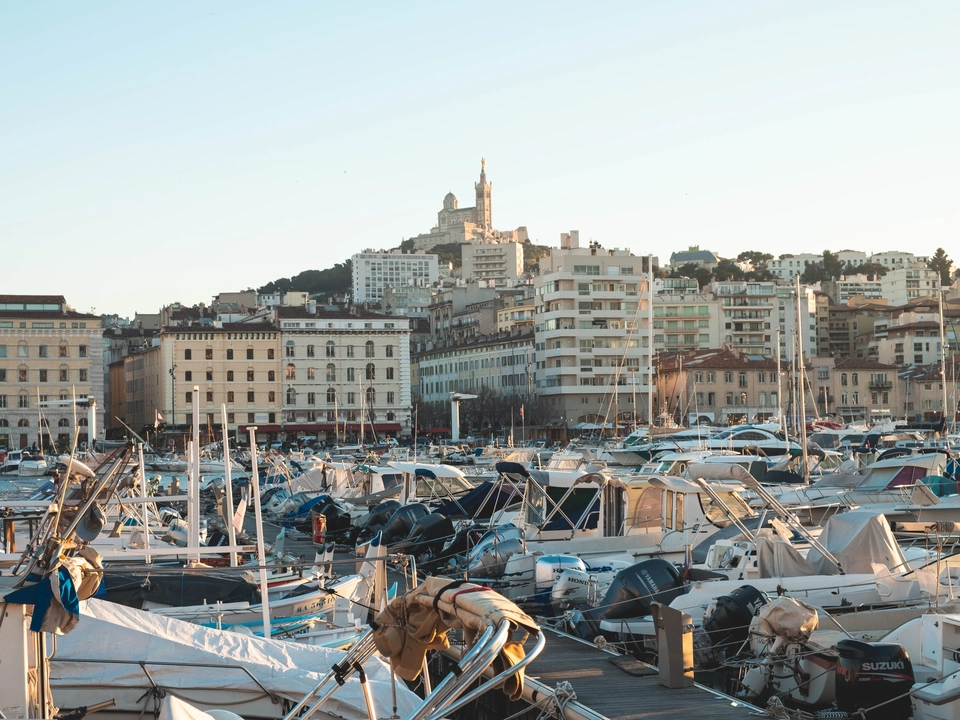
<box><xmin>693</xmin><ymin>585</ymin><xmax>767</xmax><ymax>669</ymax></box>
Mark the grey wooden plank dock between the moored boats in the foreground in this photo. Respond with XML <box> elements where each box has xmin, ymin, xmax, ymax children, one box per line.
<box><xmin>525</xmin><ymin>630</ymin><xmax>759</xmax><ymax>720</ymax></box>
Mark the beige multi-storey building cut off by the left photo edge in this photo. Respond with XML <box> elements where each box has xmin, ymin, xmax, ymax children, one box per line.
<box><xmin>0</xmin><ymin>295</ymin><xmax>104</xmax><ymax>450</ymax></box>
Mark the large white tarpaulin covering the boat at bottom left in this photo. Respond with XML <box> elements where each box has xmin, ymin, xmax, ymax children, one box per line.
<box><xmin>51</xmin><ymin>600</ymin><xmax>420</xmax><ymax>720</ymax></box>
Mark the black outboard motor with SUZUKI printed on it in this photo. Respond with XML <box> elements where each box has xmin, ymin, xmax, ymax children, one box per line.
<box><xmin>836</xmin><ymin>640</ymin><xmax>914</xmax><ymax>720</ymax></box>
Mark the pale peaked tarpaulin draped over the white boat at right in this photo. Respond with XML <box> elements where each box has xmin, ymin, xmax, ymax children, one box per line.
<box><xmin>807</xmin><ymin>510</ymin><xmax>906</xmax><ymax>575</ymax></box>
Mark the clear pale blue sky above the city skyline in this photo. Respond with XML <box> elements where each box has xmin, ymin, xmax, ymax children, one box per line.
<box><xmin>0</xmin><ymin>0</ymin><xmax>960</xmax><ymax>316</ymax></box>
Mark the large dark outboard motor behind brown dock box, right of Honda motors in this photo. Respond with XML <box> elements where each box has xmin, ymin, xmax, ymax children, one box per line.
<box><xmin>576</xmin><ymin>558</ymin><xmax>685</xmax><ymax>640</ymax></box>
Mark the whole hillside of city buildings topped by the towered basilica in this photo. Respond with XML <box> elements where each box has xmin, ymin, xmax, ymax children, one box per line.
<box><xmin>0</xmin><ymin>164</ymin><xmax>960</xmax><ymax>449</ymax></box>
